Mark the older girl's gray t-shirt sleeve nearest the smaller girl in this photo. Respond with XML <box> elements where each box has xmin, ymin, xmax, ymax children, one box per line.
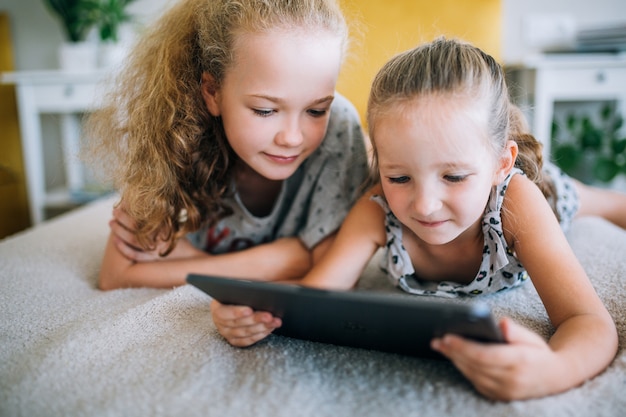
<box><xmin>298</xmin><ymin>94</ymin><xmax>368</xmax><ymax>249</ymax></box>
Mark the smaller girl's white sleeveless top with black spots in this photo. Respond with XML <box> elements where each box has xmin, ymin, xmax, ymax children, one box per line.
<box><xmin>371</xmin><ymin>164</ymin><xmax>579</xmax><ymax>297</ymax></box>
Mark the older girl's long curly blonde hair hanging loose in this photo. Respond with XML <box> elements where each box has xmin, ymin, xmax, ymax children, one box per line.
<box><xmin>85</xmin><ymin>0</ymin><xmax>348</xmax><ymax>255</ymax></box>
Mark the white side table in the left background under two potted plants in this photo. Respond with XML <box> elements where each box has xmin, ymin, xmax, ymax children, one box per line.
<box><xmin>2</xmin><ymin>71</ymin><xmax>106</xmax><ymax>224</ymax></box>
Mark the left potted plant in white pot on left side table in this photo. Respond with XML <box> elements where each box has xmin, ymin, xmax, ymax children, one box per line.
<box><xmin>44</xmin><ymin>0</ymin><xmax>100</xmax><ymax>71</ymax></box>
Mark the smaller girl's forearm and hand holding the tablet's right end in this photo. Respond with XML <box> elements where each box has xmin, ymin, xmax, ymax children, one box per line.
<box><xmin>432</xmin><ymin>311</ymin><xmax>617</xmax><ymax>401</ymax></box>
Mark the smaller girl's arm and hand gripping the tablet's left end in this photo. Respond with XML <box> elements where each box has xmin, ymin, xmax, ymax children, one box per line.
<box><xmin>211</xmin><ymin>188</ymin><xmax>386</xmax><ymax>347</ymax></box>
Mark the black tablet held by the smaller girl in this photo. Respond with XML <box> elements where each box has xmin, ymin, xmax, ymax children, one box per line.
<box><xmin>187</xmin><ymin>274</ymin><xmax>503</xmax><ymax>358</ymax></box>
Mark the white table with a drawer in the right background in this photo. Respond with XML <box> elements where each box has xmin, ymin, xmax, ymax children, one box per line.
<box><xmin>506</xmin><ymin>53</ymin><xmax>626</xmax><ymax>157</ymax></box>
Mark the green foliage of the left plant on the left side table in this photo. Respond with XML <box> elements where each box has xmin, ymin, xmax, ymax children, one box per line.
<box><xmin>44</xmin><ymin>0</ymin><xmax>100</xmax><ymax>42</ymax></box>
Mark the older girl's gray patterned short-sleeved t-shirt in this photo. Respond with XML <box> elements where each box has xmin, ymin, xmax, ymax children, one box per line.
<box><xmin>188</xmin><ymin>94</ymin><xmax>368</xmax><ymax>254</ymax></box>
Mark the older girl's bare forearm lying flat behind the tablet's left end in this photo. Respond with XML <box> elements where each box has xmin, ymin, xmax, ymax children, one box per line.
<box><xmin>98</xmin><ymin>234</ymin><xmax>312</xmax><ymax>290</ymax></box>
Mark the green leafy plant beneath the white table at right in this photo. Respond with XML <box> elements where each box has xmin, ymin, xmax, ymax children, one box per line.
<box><xmin>552</xmin><ymin>103</ymin><xmax>626</xmax><ymax>182</ymax></box>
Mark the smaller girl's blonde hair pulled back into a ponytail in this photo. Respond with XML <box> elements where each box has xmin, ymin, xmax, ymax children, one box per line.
<box><xmin>367</xmin><ymin>37</ymin><xmax>556</xmax><ymax>213</ymax></box>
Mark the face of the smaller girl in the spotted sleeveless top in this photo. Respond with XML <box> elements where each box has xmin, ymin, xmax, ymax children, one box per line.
<box><xmin>373</xmin><ymin>96</ymin><xmax>506</xmax><ymax>245</ymax></box>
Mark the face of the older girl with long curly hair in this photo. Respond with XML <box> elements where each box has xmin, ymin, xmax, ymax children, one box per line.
<box><xmin>202</xmin><ymin>30</ymin><xmax>342</xmax><ymax>180</ymax></box>
